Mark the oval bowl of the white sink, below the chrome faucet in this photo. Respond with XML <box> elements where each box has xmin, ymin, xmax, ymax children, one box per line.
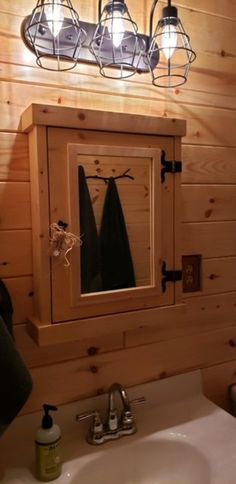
<box><xmin>69</xmin><ymin>438</ymin><xmax>211</xmax><ymax>484</ymax></box>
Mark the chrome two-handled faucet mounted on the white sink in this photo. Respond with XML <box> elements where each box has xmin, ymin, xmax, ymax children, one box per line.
<box><xmin>76</xmin><ymin>383</ymin><xmax>145</xmax><ymax>445</ymax></box>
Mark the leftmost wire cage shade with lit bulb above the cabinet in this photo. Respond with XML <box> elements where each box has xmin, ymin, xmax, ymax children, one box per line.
<box><xmin>22</xmin><ymin>0</ymin><xmax>86</xmax><ymax>71</ymax></box>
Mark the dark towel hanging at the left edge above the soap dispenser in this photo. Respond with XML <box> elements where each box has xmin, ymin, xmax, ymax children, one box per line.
<box><xmin>0</xmin><ymin>281</ymin><xmax>33</xmax><ymax>436</ymax></box>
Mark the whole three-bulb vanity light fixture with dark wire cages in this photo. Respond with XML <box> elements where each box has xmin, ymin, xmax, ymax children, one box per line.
<box><xmin>21</xmin><ymin>0</ymin><xmax>196</xmax><ymax>87</ymax></box>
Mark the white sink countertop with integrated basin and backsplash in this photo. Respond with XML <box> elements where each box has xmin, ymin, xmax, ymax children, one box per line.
<box><xmin>0</xmin><ymin>372</ymin><xmax>236</xmax><ymax>484</ymax></box>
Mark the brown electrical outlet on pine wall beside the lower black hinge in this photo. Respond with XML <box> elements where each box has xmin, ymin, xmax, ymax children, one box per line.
<box><xmin>182</xmin><ymin>255</ymin><xmax>202</xmax><ymax>292</ymax></box>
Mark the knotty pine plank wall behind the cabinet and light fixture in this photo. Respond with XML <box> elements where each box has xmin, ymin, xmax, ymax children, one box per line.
<box><xmin>0</xmin><ymin>0</ymin><xmax>236</xmax><ymax>412</ymax></box>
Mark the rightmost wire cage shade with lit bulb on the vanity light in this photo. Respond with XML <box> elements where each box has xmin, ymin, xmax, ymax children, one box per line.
<box><xmin>148</xmin><ymin>1</ymin><xmax>196</xmax><ymax>87</ymax></box>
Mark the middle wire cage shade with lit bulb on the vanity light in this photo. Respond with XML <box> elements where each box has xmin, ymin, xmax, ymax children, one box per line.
<box><xmin>90</xmin><ymin>0</ymin><xmax>145</xmax><ymax>79</ymax></box>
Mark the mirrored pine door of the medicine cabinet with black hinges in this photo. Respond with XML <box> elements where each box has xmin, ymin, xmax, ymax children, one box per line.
<box><xmin>48</xmin><ymin>128</ymin><xmax>174</xmax><ymax>323</ymax></box>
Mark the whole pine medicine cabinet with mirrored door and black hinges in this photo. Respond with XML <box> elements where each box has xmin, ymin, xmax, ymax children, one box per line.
<box><xmin>22</xmin><ymin>104</ymin><xmax>186</xmax><ymax>345</ymax></box>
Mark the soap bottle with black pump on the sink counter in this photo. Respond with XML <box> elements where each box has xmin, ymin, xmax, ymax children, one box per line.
<box><xmin>35</xmin><ymin>403</ymin><xmax>61</xmax><ymax>482</ymax></box>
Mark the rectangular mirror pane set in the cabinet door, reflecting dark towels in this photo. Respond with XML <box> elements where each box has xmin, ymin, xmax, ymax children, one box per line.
<box><xmin>76</xmin><ymin>152</ymin><xmax>152</xmax><ymax>294</ymax></box>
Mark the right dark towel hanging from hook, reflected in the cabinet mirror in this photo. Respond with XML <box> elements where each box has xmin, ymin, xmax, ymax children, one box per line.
<box><xmin>100</xmin><ymin>177</ymin><xmax>136</xmax><ymax>291</ymax></box>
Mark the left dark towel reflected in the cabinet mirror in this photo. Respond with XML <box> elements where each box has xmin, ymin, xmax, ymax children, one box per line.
<box><xmin>78</xmin><ymin>166</ymin><xmax>102</xmax><ymax>293</ymax></box>
